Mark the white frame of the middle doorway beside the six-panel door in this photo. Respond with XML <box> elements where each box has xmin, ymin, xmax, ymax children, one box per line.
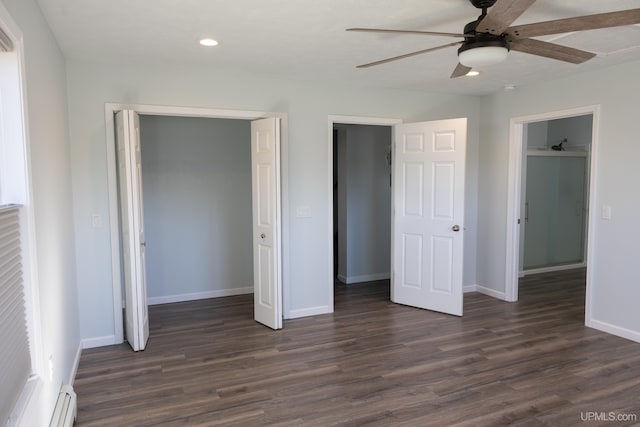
<box><xmin>326</xmin><ymin>115</ymin><xmax>402</xmax><ymax>313</ymax></box>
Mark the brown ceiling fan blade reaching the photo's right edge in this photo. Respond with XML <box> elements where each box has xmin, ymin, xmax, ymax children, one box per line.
<box><xmin>507</xmin><ymin>9</ymin><xmax>640</xmax><ymax>39</ymax></box>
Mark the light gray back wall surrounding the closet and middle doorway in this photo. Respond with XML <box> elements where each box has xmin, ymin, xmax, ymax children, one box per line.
<box><xmin>67</xmin><ymin>61</ymin><xmax>481</xmax><ymax>338</ymax></box>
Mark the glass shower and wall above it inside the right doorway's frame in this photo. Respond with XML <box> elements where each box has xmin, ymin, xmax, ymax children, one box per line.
<box><xmin>520</xmin><ymin>114</ymin><xmax>593</xmax><ymax>277</ymax></box>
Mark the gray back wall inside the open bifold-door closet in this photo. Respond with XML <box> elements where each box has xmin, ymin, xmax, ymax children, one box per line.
<box><xmin>140</xmin><ymin>116</ymin><xmax>253</xmax><ymax>302</ymax></box>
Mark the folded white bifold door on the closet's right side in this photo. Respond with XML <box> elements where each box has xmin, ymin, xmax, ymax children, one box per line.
<box><xmin>251</xmin><ymin>117</ymin><xmax>282</xmax><ymax>329</ymax></box>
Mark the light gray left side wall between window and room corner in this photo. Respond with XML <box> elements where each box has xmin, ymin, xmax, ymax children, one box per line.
<box><xmin>3</xmin><ymin>0</ymin><xmax>79</xmax><ymax>426</ymax></box>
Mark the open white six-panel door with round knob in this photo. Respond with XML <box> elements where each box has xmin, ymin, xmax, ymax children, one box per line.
<box><xmin>391</xmin><ymin>118</ymin><xmax>467</xmax><ymax>316</ymax></box>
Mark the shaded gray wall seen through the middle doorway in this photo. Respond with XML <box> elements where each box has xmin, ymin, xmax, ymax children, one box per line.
<box><xmin>338</xmin><ymin>125</ymin><xmax>391</xmax><ymax>283</ymax></box>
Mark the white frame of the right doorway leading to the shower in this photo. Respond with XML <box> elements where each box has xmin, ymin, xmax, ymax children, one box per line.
<box><xmin>505</xmin><ymin>105</ymin><xmax>600</xmax><ymax>325</ymax></box>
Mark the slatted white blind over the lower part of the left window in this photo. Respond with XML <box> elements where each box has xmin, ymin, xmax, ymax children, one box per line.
<box><xmin>0</xmin><ymin>206</ymin><xmax>31</xmax><ymax>424</ymax></box>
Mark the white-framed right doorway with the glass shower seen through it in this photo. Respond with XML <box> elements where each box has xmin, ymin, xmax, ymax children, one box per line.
<box><xmin>505</xmin><ymin>106</ymin><xmax>598</xmax><ymax>316</ymax></box>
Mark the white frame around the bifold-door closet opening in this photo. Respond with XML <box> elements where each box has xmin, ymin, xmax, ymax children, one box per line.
<box><xmin>105</xmin><ymin>103</ymin><xmax>290</xmax><ymax>344</ymax></box>
